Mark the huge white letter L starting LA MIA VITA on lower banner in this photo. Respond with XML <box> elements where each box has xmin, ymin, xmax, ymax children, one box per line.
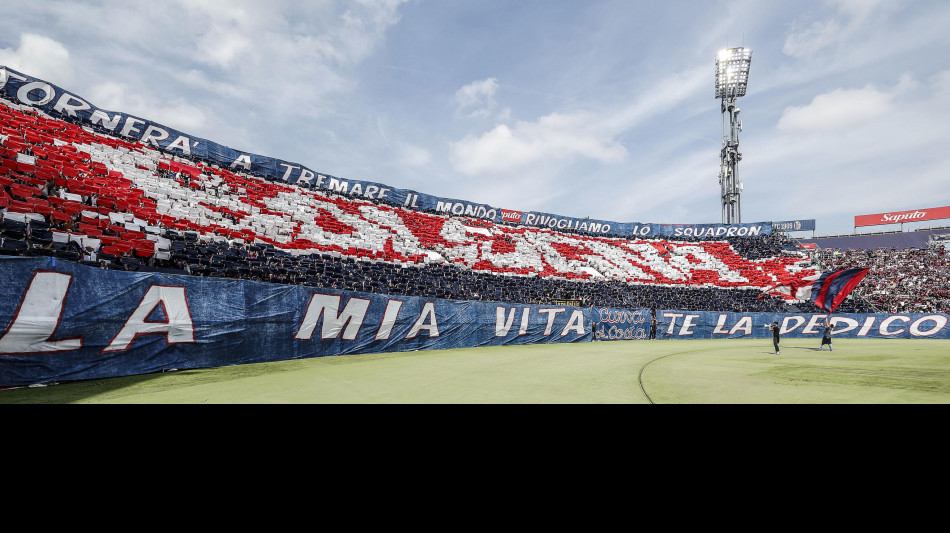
<box><xmin>0</xmin><ymin>271</ymin><xmax>82</xmax><ymax>354</ymax></box>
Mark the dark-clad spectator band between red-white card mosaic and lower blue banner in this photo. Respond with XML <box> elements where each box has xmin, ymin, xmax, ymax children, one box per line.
<box><xmin>0</xmin><ymin>209</ymin><xmax>812</xmax><ymax>312</ymax></box>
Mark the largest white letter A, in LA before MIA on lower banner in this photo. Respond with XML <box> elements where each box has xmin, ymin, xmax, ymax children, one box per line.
<box><xmin>102</xmin><ymin>285</ymin><xmax>195</xmax><ymax>353</ymax></box>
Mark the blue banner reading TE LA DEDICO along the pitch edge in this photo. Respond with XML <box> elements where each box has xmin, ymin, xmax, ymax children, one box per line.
<box><xmin>657</xmin><ymin>310</ymin><xmax>950</xmax><ymax>339</ymax></box>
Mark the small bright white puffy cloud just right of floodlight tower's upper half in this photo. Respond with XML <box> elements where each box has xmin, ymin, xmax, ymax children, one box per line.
<box><xmin>776</xmin><ymin>76</ymin><xmax>916</xmax><ymax>132</ymax></box>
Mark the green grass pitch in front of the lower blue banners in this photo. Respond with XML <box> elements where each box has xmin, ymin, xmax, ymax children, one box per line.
<box><xmin>0</xmin><ymin>339</ymin><xmax>950</xmax><ymax>405</ymax></box>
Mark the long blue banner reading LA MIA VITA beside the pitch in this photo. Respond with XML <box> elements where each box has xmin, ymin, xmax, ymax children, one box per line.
<box><xmin>0</xmin><ymin>257</ymin><xmax>593</xmax><ymax>387</ymax></box>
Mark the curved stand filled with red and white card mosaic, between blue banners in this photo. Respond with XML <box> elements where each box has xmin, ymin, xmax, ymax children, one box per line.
<box><xmin>0</xmin><ymin>95</ymin><xmax>872</xmax><ymax>312</ymax></box>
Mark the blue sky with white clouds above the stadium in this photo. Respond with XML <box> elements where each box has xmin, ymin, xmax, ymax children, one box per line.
<box><xmin>0</xmin><ymin>0</ymin><xmax>950</xmax><ymax>237</ymax></box>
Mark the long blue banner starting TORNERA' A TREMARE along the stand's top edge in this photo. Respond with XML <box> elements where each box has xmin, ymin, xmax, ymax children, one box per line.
<box><xmin>0</xmin><ymin>66</ymin><xmax>772</xmax><ymax>239</ymax></box>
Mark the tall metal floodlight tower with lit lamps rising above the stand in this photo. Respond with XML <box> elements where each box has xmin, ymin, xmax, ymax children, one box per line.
<box><xmin>716</xmin><ymin>48</ymin><xmax>752</xmax><ymax>224</ymax></box>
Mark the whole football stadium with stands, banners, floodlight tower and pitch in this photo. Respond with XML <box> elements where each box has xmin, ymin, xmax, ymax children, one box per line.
<box><xmin>0</xmin><ymin>4</ymin><xmax>950</xmax><ymax>404</ymax></box>
